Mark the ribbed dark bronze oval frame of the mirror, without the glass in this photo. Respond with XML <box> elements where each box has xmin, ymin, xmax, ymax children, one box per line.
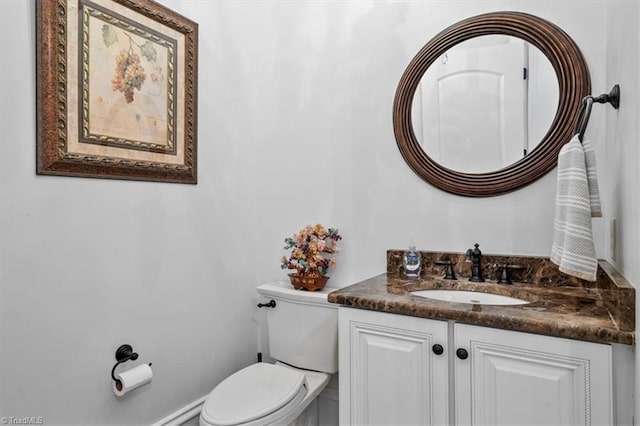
<box><xmin>393</xmin><ymin>12</ymin><xmax>591</xmax><ymax>197</ymax></box>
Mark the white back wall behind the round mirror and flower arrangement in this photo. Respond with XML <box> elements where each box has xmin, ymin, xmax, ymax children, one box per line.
<box><xmin>164</xmin><ymin>1</ymin><xmax>606</xmax><ymax>287</ymax></box>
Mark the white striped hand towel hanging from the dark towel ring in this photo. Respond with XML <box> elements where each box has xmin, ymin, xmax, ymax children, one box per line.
<box><xmin>551</xmin><ymin>136</ymin><xmax>602</xmax><ymax>281</ymax></box>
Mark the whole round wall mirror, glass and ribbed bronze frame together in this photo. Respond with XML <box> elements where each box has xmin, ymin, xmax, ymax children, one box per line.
<box><xmin>393</xmin><ymin>12</ymin><xmax>590</xmax><ymax>197</ymax></box>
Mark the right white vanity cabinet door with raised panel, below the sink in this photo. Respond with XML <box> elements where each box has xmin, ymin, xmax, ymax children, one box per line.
<box><xmin>450</xmin><ymin>324</ymin><xmax>613</xmax><ymax>426</ymax></box>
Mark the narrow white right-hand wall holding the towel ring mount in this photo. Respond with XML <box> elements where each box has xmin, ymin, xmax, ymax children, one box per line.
<box><xmin>604</xmin><ymin>2</ymin><xmax>640</xmax><ymax>422</ymax></box>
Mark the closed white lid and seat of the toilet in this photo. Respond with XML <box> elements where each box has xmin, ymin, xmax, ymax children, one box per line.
<box><xmin>200</xmin><ymin>362</ymin><xmax>308</xmax><ymax>426</ymax></box>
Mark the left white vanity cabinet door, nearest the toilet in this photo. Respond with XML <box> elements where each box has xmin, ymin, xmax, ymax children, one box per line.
<box><xmin>339</xmin><ymin>307</ymin><xmax>449</xmax><ymax>425</ymax></box>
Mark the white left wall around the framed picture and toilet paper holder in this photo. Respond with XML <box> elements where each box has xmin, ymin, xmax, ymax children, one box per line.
<box><xmin>0</xmin><ymin>0</ymin><xmax>260</xmax><ymax>425</ymax></box>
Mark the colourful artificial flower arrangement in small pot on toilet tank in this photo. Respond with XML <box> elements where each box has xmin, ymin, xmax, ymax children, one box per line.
<box><xmin>281</xmin><ymin>223</ymin><xmax>342</xmax><ymax>290</ymax></box>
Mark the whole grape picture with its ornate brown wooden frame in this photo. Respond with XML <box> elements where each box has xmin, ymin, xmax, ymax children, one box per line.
<box><xmin>36</xmin><ymin>0</ymin><xmax>198</xmax><ymax>183</ymax></box>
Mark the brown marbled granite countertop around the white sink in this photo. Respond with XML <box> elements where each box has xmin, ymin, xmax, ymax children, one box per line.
<box><xmin>328</xmin><ymin>251</ymin><xmax>635</xmax><ymax>345</ymax></box>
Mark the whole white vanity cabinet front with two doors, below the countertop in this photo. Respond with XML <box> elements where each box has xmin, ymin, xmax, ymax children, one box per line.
<box><xmin>339</xmin><ymin>307</ymin><xmax>613</xmax><ymax>426</ymax></box>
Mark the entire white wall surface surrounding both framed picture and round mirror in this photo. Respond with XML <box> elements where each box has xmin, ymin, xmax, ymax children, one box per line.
<box><xmin>0</xmin><ymin>0</ymin><xmax>638</xmax><ymax>425</ymax></box>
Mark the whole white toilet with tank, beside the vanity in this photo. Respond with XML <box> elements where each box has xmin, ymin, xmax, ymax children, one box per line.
<box><xmin>200</xmin><ymin>282</ymin><xmax>338</xmax><ymax>426</ymax></box>
